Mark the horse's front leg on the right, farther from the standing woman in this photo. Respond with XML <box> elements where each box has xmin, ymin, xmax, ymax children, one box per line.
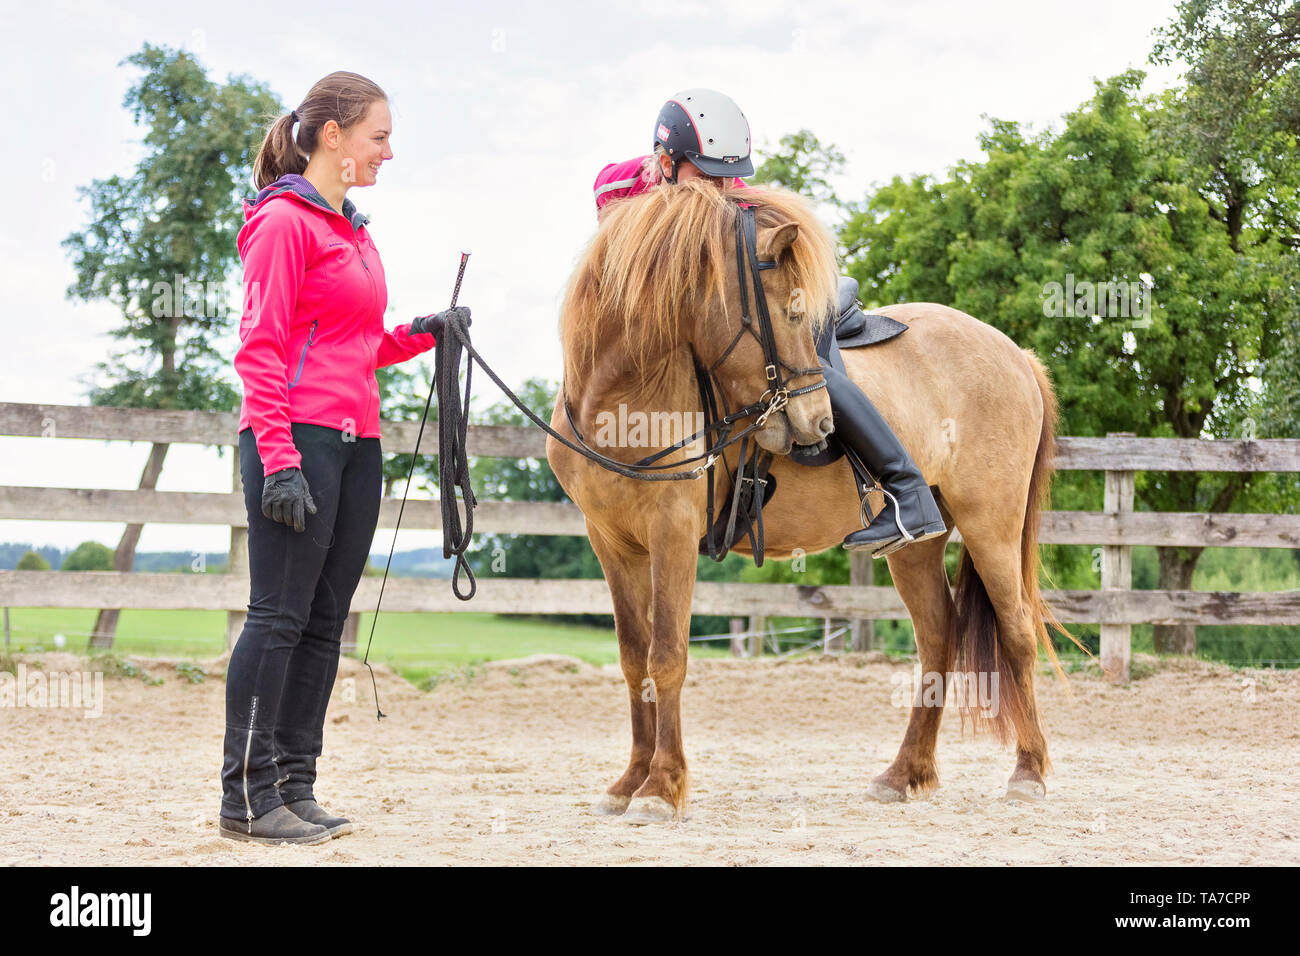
<box><xmin>624</xmin><ymin>507</ymin><xmax>698</xmax><ymax>823</ymax></box>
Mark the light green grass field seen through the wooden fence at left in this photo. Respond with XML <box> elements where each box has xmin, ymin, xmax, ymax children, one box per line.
<box><xmin>0</xmin><ymin>607</ymin><xmax>727</xmax><ymax>685</ymax></box>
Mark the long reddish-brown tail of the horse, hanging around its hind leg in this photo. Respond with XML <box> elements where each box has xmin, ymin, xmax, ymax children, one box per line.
<box><xmin>953</xmin><ymin>349</ymin><xmax>1083</xmax><ymax>744</ymax></box>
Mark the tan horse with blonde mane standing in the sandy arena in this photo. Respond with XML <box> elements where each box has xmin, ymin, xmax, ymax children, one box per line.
<box><xmin>546</xmin><ymin>182</ymin><xmax>1063</xmax><ymax>823</ymax></box>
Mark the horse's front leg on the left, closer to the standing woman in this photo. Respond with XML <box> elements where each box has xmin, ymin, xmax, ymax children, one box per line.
<box><xmin>588</xmin><ymin>523</ymin><xmax>657</xmax><ymax>814</ymax></box>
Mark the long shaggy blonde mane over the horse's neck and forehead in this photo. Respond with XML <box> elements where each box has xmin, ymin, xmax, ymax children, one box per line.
<box><xmin>560</xmin><ymin>181</ymin><xmax>839</xmax><ymax>381</ymax></box>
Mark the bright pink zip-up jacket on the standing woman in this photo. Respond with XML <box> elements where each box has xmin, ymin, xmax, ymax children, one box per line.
<box><xmin>234</xmin><ymin>174</ymin><xmax>434</xmax><ymax>475</ymax></box>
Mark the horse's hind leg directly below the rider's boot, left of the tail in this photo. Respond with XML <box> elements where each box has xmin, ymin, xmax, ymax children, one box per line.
<box><xmin>867</xmin><ymin>528</ymin><xmax>954</xmax><ymax>803</ymax></box>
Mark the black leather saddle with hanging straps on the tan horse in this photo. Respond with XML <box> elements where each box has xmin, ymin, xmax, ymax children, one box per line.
<box><xmin>699</xmin><ymin>276</ymin><xmax>907</xmax><ymax>556</ymax></box>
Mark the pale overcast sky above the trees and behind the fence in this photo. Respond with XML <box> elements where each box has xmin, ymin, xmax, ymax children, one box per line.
<box><xmin>0</xmin><ymin>0</ymin><xmax>1177</xmax><ymax>550</ymax></box>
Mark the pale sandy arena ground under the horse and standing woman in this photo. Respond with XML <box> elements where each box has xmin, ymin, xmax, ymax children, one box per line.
<box><xmin>0</xmin><ymin>654</ymin><xmax>1300</xmax><ymax>865</ymax></box>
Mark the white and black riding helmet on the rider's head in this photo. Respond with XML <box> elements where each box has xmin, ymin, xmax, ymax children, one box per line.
<box><xmin>654</xmin><ymin>90</ymin><xmax>754</xmax><ymax>179</ymax></box>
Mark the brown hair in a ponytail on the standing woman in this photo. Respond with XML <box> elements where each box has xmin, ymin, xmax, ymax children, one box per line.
<box><xmin>252</xmin><ymin>70</ymin><xmax>389</xmax><ymax>189</ymax></box>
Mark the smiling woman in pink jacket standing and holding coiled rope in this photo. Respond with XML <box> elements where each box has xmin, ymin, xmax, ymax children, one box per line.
<box><xmin>220</xmin><ymin>72</ymin><xmax>469</xmax><ymax>844</ymax></box>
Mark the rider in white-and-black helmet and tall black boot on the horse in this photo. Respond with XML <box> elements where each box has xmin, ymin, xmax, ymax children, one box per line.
<box><xmin>594</xmin><ymin>90</ymin><xmax>946</xmax><ymax>558</ymax></box>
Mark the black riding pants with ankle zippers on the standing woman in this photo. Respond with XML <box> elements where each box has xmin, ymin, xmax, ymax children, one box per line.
<box><xmin>221</xmin><ymin>424</ymin><xmax>382</xmax><ymax>819</ymax></box>
